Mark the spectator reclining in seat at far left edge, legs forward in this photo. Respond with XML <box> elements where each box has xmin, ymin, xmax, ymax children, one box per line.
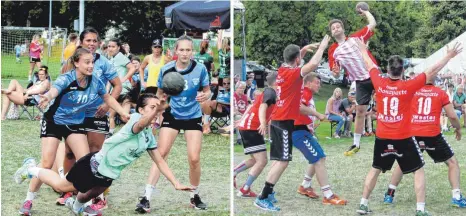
<box><xmin>2</xmin><ymin>65</ymin><xmax>50</xmax><ymax>120</ymax></box>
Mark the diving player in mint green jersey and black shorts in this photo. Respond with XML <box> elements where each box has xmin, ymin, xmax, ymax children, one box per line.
<box><xmin>14</xmin><ymin>93</ymin><xmax>193</xmax><ymax>215</ymax></box>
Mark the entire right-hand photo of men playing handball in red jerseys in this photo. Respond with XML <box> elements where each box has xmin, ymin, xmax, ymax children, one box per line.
<box><xmin>232</xmin><ymin>1</ymin><xmax>466</xmax><ymax>216</ymax></box>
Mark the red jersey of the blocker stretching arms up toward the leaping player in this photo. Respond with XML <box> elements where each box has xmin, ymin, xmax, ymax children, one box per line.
<box><xmin>271</xmin><ymin>65</ymin><xmax>303</xmax><ymax>121</ymax></box>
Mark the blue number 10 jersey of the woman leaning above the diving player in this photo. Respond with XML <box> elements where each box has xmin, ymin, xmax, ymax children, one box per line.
<box><xmin>44</xmin><ymin>69</ymin><xmax>106</xmax><ymax>125</ymax></box>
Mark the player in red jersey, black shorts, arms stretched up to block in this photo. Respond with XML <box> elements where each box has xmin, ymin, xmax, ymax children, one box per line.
<box><xmin>254</xmin><ymin>35</ymin><xmax>330</xmax><ymax>211</ymax></box>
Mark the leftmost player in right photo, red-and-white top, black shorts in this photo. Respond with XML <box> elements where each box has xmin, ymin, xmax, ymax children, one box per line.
<box><xmin>234</xmin><ymin>71</ymin><xmax>277</xmax><ymax>197</ymax></box>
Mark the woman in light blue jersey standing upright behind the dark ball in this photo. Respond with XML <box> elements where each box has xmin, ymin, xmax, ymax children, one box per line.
<box><xmin>136</xmin><ymin>36</ymin><xmax>210</xmax><ymax>213</ymax></box>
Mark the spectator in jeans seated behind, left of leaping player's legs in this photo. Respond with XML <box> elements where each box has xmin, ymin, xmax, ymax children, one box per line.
<box><xmin>325</xmin><ymin>88</ymin><xmax>345</xmax><ymax>139</ymax></box>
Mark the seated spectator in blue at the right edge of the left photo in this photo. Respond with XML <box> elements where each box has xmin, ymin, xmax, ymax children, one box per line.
<box><xmin>202</xmin><ymin>77</ymin><xmax>230</xmax><ymax>134</ymax></box>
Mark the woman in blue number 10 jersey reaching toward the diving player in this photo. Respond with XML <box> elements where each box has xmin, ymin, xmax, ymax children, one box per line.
<box><xmin>20</xmin><ymin>48</ymin><xmax>129</xmax><ymax>215</ymax></box>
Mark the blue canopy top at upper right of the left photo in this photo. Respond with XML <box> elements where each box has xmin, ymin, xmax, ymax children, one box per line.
<box><xmin>165</xmin><ymin>0</ymin><xmax>230</xmax><ymax>31</ymax></box>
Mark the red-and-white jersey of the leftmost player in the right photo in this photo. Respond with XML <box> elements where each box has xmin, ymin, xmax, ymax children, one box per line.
<box><xmin>239</xmin><ymin>88</ymin><xmax>276</xmax><ymax>130</ymax></box>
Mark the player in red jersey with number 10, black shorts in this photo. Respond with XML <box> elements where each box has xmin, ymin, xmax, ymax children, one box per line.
<box><xmin>384</xmin><ymin>77</ymin><xmax>466</xmax><ymax>208</ymax></box>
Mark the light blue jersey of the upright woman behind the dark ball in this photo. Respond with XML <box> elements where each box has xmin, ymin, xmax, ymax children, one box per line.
<box><xmin>157</xmin><ymin>60</ymin><xmax>209</xmax><ymax>120</ymax></box>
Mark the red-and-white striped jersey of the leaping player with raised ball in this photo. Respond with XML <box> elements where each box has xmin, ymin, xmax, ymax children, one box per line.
<box><xmin>328</xmin><ymin>26</ymin><xmax>377</xmax><ymax>81</ymax></box>
